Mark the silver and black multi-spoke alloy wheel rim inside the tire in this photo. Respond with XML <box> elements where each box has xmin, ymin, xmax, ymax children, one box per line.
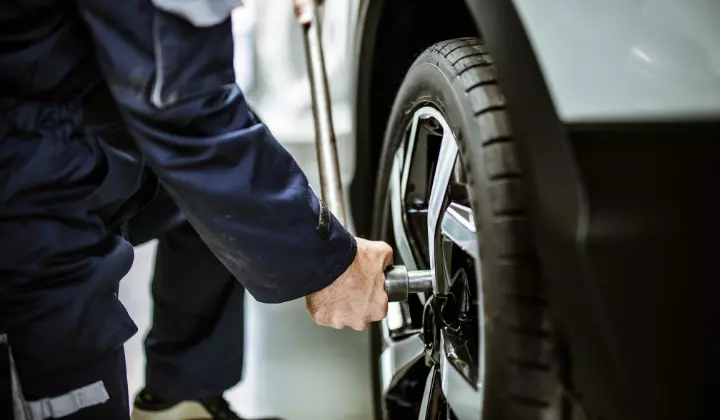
<box><xmin>380</xmin><ymin>106</ymin><xmax>485</xmax><ymax>420</ymax></box>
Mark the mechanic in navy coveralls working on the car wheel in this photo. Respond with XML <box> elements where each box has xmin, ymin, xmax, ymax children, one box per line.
<box><xmin>0</xmin><ymin>0</ymin><xmax>392</xmax><ymax>420</ymax></box>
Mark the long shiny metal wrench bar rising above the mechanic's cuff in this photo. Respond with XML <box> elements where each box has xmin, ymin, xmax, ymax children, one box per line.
<box><xmin>303</xmin><ymin>1</ymin><xmax>347</xmax><ymax>226</ymax></box>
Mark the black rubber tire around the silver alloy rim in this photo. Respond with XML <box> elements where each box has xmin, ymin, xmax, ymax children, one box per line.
<box><xmin>373</xmin><ymin>38</ymin><xmax>562</xmax><ymax>420</ymax></box>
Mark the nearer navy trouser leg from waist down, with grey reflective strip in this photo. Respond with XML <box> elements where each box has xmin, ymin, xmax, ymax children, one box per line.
<box><xmin>0</xmin><ymin>83</ymin><xmax>170</xmax><ymax>420</ymax></box>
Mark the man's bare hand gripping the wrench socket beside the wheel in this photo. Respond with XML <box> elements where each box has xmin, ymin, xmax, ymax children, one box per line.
<box><xmin>305</xmin><ymin>238</ymin><xmax>393</xmax><ymax>331</ymax></box>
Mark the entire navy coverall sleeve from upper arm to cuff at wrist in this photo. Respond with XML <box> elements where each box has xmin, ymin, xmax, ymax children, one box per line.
<box><xmin>77</xmin><ymin>0</ymin><xmax>356</xmax><ymax>303</ymax></box>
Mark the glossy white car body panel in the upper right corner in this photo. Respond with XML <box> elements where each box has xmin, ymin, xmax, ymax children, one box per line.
<box><xmin>514</xmin><ymin>0</ymin><xmax>720</xmax><ymax>123</ymax></box>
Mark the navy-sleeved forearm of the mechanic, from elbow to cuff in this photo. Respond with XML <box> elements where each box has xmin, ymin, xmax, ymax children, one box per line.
<box><xmin>130</xmin><ymin>95</ymin><xmax>355</xmax><ymax>302</ymax></box>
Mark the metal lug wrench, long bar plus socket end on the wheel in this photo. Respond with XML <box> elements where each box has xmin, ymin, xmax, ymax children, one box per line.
<box><xmin>303</xmin><ymin>0</ymin><xmax>432</xmax><ymax>302</ymax></box>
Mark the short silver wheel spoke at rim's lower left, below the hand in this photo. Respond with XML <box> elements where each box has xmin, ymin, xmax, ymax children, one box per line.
<box><xmin>381</xmin><ymin>333</ymin><xmax>425</xmax><ymax>393</ymax></box>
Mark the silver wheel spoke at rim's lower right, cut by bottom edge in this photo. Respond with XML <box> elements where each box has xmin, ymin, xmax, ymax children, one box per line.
<box><xmin>440</xmin><ymin>332</ymin><xmax>483</xmax><ymax>420</ymax></box>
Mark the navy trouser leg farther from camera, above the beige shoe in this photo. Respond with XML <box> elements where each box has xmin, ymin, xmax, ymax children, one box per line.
<box><xmin>145</xmin><ymin>223</ymin><xmax>245</xmax><ymax>401</ymax></box>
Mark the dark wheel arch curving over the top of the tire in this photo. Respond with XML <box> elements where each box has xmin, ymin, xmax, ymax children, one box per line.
<box><xmin>350</xmin><ymin>0</ymin><xmax>560</xmax><ymax>235</ymax></box>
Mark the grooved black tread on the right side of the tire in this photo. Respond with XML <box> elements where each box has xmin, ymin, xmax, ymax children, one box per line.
<box><xmin>426</xmin><ymin>38</ymin><xmax>559</xmax><ymax>420</ymax></box>
